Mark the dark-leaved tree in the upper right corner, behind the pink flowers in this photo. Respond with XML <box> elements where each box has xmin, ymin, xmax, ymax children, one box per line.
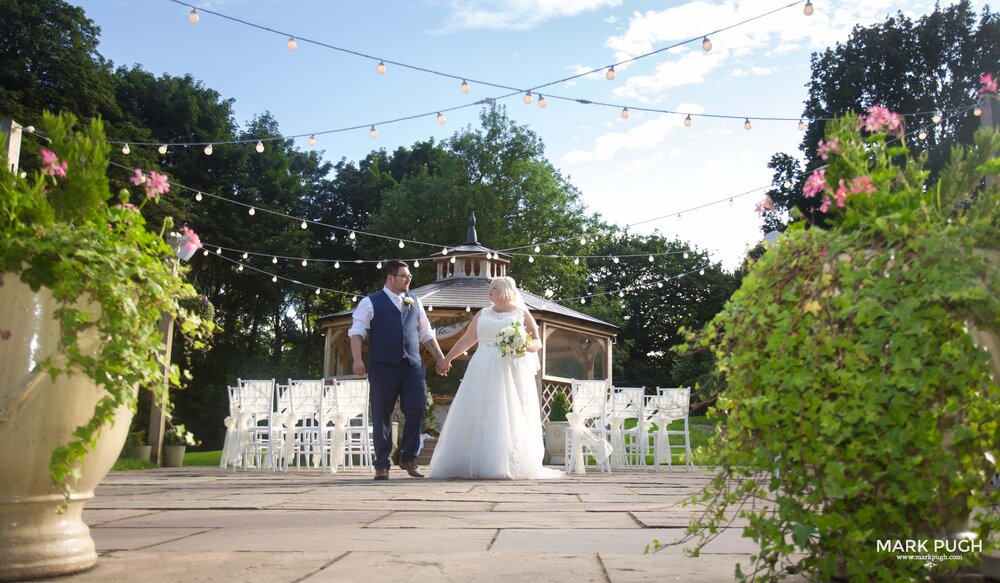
<box><xmin>764</xmin><ymin>0</ymin><xmax>1000</xmax><ymax>232</ymax></box>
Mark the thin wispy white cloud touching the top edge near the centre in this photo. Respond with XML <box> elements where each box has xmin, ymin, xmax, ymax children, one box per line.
<box><xmin>445</xmin><ymin>0</ymin><xmax>622</xmax><ymax>32</ymax></box>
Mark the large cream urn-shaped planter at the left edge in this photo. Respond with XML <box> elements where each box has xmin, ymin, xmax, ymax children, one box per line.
<box><xmin>0</xmin><ymin>273</ymin><xmax>131</xmax><ymax>581</ymax></box>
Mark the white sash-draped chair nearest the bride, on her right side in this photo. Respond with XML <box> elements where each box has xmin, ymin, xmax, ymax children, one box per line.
<box><xmin>566</xmin><ymin>380</ymin><xmax>612</xmax><ymax>474</ymax></box>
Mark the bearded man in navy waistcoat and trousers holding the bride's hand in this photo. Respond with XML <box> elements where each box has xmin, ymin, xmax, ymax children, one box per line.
<box><xmin>348</xmin><ymin>260</ymin><xmax>451</xmax><ymax>480</ymax></box>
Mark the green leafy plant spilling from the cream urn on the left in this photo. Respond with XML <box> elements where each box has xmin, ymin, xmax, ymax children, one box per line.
<box><xmin>0</xmin><ymin>114</ymin><xmax>213</xmax><ymax>496</ymax></box>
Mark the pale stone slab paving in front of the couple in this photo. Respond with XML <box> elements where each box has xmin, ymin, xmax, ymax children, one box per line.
<box><xmin>56</xmin><ymin>467</ymin><xmax>799</xmax><ymax>583</ymax></box>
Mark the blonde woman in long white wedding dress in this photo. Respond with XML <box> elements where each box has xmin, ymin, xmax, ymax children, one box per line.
<box><xmin>428</xmin><ymin>277</ymin><xmax>563</xmax><ymax>480</ymax></box>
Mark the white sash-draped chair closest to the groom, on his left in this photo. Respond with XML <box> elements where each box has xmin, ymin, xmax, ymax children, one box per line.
<box><xmin>323</xmin><ymin>378</ymin><xmax>374</xmax><ymax>473</ymax></box>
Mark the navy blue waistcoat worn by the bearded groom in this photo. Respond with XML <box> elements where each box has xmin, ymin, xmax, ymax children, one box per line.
<box><xmin>368</xmin><ymin>290</ymin><xmax>421</xmax><ymax>366</ymax></box>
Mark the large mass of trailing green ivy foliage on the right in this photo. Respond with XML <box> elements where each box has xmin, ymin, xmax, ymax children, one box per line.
<box><xmin>684</xmin><ymin>116</ymin><xmax>1000</xmax><ymax>581</ymax></box>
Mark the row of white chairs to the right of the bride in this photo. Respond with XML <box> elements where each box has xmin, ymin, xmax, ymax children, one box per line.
<box><xmin>566</xmin><ymin>380</ymin><xmax>694</xmax><ymax>473</ymax></box>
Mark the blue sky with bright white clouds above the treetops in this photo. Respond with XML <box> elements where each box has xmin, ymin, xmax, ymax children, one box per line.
<box><xmin>71</xmin><ymin>0</ymin><xmax>968</xmax><ymax>268</ymax></box>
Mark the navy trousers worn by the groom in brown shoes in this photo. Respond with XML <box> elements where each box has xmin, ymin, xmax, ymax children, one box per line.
<box><xmin>368</xmin><ymin>358</ymin><xmax>427</xmax><ymax>468</ymax></box>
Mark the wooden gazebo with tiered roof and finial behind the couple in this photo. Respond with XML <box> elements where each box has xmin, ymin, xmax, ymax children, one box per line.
<box><xmin>320</xmin><ymin>212</ymin><xmax>618</xmax><ymax>419</ymax></box>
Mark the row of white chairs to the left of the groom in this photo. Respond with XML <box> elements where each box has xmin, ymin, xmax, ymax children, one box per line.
<box><xmin>220</xmin><ymin>378</ymin><xmax>373</xmax><ymax>472</ymax></box>
